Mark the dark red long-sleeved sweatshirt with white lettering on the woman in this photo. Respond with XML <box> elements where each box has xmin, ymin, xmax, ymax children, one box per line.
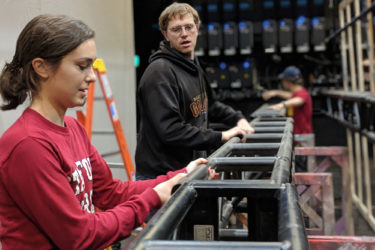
<box><xmin>0</xmin><ymin>109</ymin><xmax>183</xmax><ymax>250</ymax></box>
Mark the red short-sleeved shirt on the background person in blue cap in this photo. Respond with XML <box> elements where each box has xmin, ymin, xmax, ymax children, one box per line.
<box><xmin>291</xmin><ymin>88</ymin><xmax>314</xmax><ymax>134</ymax></box>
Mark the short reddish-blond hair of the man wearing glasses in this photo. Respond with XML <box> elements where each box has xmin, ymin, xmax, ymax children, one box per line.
<box><xmin>159</xmin><ymin>3</ymin><xmax>201</xmax><ymax>31</ymax></box>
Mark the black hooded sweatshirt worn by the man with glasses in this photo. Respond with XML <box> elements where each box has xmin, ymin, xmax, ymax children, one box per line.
<box><xmin>135</xmin><ymin>42</ymin><xmax>244</xmax><ymax>178</ymax></box>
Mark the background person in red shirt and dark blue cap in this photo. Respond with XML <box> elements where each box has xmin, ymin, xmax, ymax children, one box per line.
<box><xmin>263</xmin><ymin>66</ymin><xmax>315</xmax><ymax>171</ymax></box>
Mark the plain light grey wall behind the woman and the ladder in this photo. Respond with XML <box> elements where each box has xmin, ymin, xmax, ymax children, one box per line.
<box><xmin>0</xmin><ymin>0</ymin><xmax>136</xmax><ymax>179</ymax></box>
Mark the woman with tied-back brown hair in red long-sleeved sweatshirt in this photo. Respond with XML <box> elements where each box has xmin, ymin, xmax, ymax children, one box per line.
<box><xmin>0</xmin><ymin>15</ymin><xmax>214</xmax><ymax>249</ymax></box>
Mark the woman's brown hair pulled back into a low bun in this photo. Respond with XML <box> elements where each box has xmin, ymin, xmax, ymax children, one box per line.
<box><xmin>0</xmin><ymin>15</ymin><xmax>95</xmax><ymax>110</ymax></box>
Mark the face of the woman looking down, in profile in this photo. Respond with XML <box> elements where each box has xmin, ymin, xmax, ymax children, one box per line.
<box><xmin>43</xmin><ymin>39</ymin><xmax>96</xmax><ymax>110</ymax></box>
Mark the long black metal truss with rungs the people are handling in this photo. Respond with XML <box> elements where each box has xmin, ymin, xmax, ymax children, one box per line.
<box><xmin>126</xmin><ymin>107</ymin><xmax>309</xmax><ymax>249</ymax></box>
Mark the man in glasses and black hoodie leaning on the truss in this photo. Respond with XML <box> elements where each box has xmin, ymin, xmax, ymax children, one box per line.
<box><xmin>135</xmin><ymin>3</ymin><xmax>253</xmax><ymax>179</ymax></box>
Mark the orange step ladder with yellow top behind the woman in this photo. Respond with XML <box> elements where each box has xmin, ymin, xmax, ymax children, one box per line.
<box><xmin>77</xmin><ymin>59</ymin><xmax>135</xmax><ymax>181</ymax></box>
